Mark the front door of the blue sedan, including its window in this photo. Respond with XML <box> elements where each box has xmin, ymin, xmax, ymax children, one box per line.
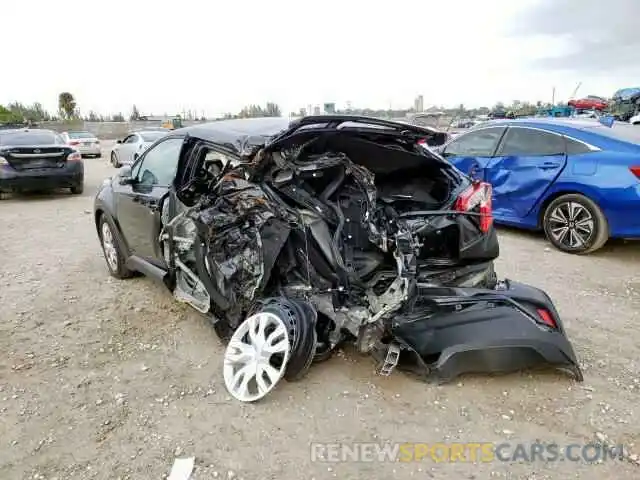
<box><xmin>442</xmin><ymin>126</ymin><xmax>506</xmax><ymax>179</ymax></box>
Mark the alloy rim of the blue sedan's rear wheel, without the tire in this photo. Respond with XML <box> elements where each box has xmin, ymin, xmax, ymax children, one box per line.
<box><xmin>549</xmin><ymin>202</ymin><xmax>595</xmax><ymax>249</ymax></box>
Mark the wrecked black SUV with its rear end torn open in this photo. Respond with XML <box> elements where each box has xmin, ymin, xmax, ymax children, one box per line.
<box><xmin>95</xmin><ymin>116</ymin><xmax>582</xmax><ymax>401</ymax></box>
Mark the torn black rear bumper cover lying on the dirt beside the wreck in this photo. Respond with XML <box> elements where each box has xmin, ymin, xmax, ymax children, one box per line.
<box><xmin>391</xmin><ymin>280</ymin><xmax>583</xmax><ymax>382</ymax></box>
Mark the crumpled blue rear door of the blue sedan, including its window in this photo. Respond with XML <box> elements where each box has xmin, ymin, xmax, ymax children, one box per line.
<box><xmin>485</xmin><ymin>126</ymin><xmax>567</xmax><ymax>220</ymax></box>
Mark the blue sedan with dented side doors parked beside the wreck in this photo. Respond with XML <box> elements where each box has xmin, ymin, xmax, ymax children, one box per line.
<box><xmin>438</xmin><ymin>118</ymin><xmax>640</xmax><ymax>254</ymax></box>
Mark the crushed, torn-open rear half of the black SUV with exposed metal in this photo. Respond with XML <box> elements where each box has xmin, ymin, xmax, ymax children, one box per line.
<box><xmin>161</xmin><ymin>124</ymin><xmax>581</xmax><ymax>401</ymax></box>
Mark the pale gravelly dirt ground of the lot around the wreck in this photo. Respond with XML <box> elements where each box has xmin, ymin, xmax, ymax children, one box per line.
<box><xmin>0</xmin><ymin>142</ymin><xmax>640</xmax><ymax>480</ymax></box>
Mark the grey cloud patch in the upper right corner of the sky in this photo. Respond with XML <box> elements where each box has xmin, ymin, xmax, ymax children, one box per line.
<box><xmin>509</xmin><ymin>0</ymin><xmax>640</xmax><ymax>74</ymax></box>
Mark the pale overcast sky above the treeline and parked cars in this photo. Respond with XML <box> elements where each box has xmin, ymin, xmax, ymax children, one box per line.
<box><xmin>0</xmin><ymin>0</ymin><xmax>640</xmax><ymax>116</ymax></box>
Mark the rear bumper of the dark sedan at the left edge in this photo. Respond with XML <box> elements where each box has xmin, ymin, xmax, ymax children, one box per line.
<box><xmin>0</xmin><ymin>162</ymin><xmax>84</xmax><ymax>191</ymax></box>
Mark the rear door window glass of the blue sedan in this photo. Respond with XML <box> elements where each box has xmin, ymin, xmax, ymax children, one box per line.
<box><xmin>498</xmin><ymin>127</ymin><xmax>565</xmax><ymax>156</ymax></box>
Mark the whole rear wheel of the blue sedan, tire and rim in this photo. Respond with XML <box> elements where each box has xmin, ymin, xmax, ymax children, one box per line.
<box><xmin>542</xmin><ymin>193</ymin><xmax>609</xmax><ymax>255</ymax></box>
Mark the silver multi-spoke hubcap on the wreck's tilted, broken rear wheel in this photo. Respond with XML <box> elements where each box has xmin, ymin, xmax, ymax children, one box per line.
<box><xmin>224</xmin><ymin>312</ymin><xmax>290</xmax><ymax>402</ymax></box>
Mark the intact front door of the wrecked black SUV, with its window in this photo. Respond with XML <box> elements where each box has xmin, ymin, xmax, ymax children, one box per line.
<box><xmin>116</xmin><ymin>137</ymin><xmax>184</xmax><ymax>265</ymax></box>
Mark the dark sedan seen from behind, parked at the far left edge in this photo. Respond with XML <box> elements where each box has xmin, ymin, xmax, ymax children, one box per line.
<box><xmin>0</xmin><ymin>129</ymin><xmax>84</xmax><ymax>195</ymax></box>
